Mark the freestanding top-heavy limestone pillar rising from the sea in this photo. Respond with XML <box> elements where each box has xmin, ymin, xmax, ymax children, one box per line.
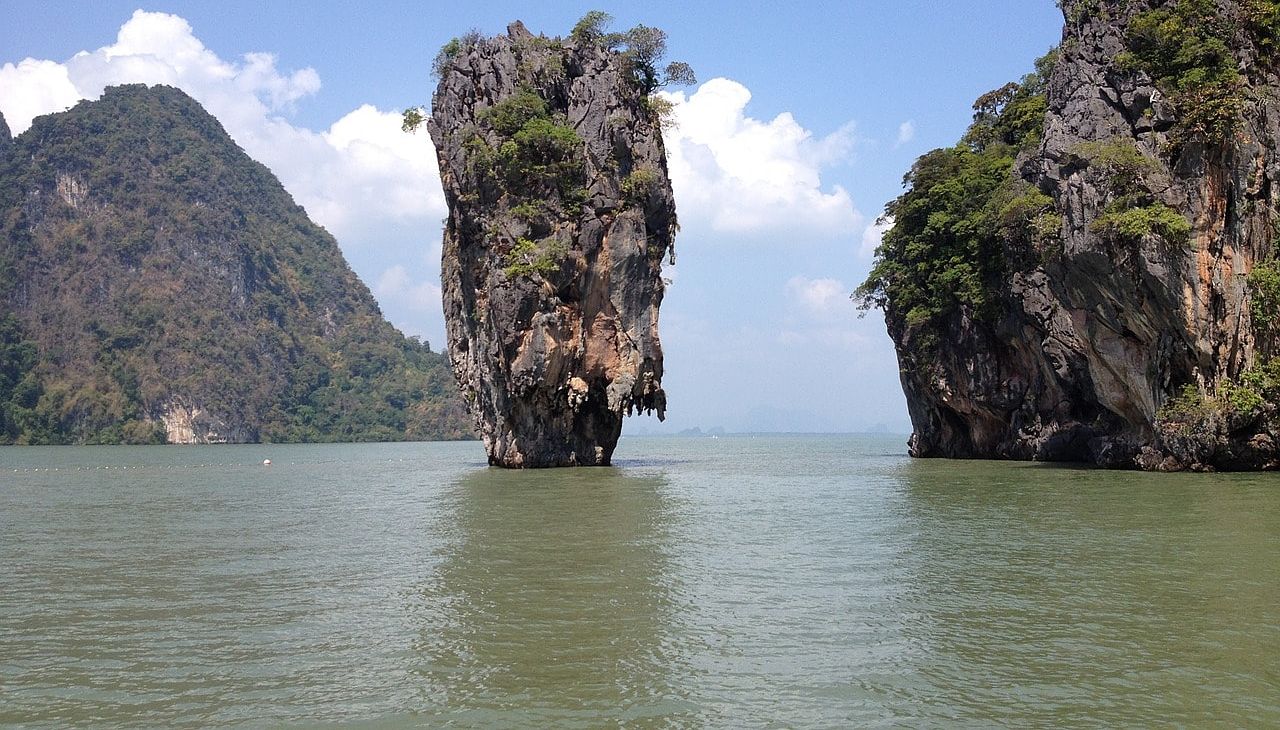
<box><xmin>429</xmin><ymin>22</ymin><xmax>676</xmax><ymax>467</ymax></box>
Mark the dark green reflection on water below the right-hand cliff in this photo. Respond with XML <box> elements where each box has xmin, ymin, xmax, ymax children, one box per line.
<box><xmin>899</xmin><ymin>461</ymin><xmax>1280</xmax><ymax>726</ymax></box>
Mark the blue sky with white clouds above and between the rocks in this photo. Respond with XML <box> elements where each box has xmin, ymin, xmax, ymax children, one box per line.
<box><xmin>0</xmin><ymin>0</ymin><xmax>1062</xmax><ymax>433</ymax></box>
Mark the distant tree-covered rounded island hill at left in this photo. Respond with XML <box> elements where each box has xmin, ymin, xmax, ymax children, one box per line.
<box><xmin>0</xmin><ymin>86</ymin><xmax>474</xmax><ymax>444</ymax></box>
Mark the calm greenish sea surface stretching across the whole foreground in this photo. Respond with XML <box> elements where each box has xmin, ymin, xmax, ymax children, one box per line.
<box><xmin>0</xmin><ymin>437</ymin><xmax>1280</xmax><ymax>727</ymax></box>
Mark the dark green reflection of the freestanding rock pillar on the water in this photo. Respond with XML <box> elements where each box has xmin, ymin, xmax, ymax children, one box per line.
<box><xmin>412</xmin><ymin>469</ymin><xmax>690</xmax><ymax>726</ymax></box>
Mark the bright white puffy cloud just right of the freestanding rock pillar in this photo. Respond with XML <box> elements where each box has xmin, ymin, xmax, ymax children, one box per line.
<box><xmin>666</xmin><ymin>78</ymin><xmax>861</xmax><ymax>237</ymax></box>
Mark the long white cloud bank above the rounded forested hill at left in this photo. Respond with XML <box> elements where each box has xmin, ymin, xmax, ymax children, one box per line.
<box><xmin>0</xmin><ymin>10</ymin><xmax>445</xmax><ymax>254</ymax></box>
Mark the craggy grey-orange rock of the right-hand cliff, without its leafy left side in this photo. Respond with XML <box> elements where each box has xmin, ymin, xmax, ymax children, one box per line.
<box><xmin>869</xmin><ymin>0</ymin><xmax>1280</xmax><ymax>470</ymax></box>
